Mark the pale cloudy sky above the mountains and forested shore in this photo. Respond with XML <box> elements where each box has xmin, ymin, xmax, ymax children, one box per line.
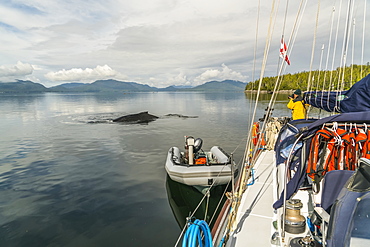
<box><xmin>0</xmin><ymin>0</ymin><xmax>370</xmax><ymax>88</ymax></box>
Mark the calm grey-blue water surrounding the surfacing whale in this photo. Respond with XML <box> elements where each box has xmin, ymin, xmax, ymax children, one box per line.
<box><xmin>0</xmin><ymin>93</ymin><xmax>290</xmax><ymax>247</ymax></box>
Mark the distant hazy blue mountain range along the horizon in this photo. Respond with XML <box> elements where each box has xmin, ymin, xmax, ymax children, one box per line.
<box><xmin>0</xmin><ymin>80</ymin><xmax>247</xmax><ymax>93</ymax></box>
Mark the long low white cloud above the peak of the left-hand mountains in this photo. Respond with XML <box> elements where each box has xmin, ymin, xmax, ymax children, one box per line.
<box><xmin>45</xmin><ymin>65</ymin><xmax>119</xmax><ymax>81</ymax></box>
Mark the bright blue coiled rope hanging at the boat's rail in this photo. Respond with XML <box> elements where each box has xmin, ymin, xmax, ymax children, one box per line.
<box><xmin>182</xmin><ymin>219</ymin><xmax>213</xmax><ymax>247</ymax></box>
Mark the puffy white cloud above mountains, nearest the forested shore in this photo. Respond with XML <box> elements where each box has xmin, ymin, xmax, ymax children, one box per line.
<box><xmin>194</xmin><ymin>64</ymin><xmax>248</xmax><ymax>85</ymax></box>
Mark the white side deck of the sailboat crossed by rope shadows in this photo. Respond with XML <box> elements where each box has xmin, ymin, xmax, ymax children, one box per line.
<box><xmin>227</xmin><ymin>151</ymin><xmax>275</xmax><ymax>247</ymax></box>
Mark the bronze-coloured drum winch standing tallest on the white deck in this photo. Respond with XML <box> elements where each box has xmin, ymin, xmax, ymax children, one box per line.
<box><xmin>285</xmin><ymin>199</ymin><xmax>306</xmax><ymax>234</ymax></box>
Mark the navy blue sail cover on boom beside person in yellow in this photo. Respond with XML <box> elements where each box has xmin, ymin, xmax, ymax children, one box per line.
<box><xmin>304</xmin><ymin>74</ymin><xmax>370</xmax><ymax>113</ymax></box>
